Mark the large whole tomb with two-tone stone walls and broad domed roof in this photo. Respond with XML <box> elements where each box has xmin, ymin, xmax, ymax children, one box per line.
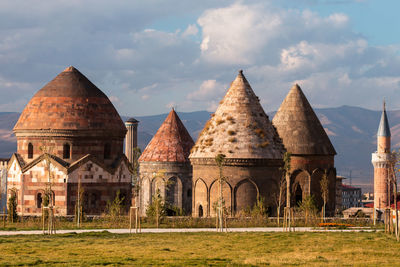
<box><xmin>7</xmin><ymin>67</ymin><xmax>132</xmax><ymax>218</ymax></box>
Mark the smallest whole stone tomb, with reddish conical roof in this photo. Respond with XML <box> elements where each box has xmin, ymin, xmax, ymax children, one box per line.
<box><xmin>139</xmin><ymin>109</ymin><xmax>194</xmax><ymax>215</ymax></box>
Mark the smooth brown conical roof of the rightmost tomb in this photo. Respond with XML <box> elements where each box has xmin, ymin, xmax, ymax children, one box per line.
<box><xmin>272</xmin><ymin>84</ymin><xmax>336</xmax><ymax>155</ymax></box>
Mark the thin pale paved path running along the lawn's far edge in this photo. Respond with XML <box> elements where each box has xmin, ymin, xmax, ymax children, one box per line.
<box><xmin>0</xmin><ymin>227</ymin><xmax>380</xmax><ymax>236</ymax></box>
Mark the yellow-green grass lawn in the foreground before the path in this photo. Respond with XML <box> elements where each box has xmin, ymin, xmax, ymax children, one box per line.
<box><xmin>0</xmin><ymin>232</ymin><xmax>400</xmax><ymax>266</ymax></box>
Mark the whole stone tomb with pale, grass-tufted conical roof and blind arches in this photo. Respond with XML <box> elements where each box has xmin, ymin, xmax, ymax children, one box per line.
<box><xmin>189</xmin><ymin>71</ymin><xmax>285</xmax><ymax>217</ymax></box>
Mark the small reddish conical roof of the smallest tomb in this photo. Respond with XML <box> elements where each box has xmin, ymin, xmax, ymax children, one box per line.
<box><xmin>139</xmin><ymin>109</ymin><xmax>194</xmax><ymax>162</ymax></box>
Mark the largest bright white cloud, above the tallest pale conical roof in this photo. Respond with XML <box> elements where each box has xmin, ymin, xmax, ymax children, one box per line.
<box><xmin>197</xmin><ymin>3</ymin><xmax>281</xmax><ymax>64</ymax></box>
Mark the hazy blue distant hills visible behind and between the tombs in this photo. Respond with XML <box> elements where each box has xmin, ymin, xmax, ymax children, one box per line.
<box><xmin>0</xmin><ymin>106</ymin><xmax>394</xmax><ymax>193</ymax></box>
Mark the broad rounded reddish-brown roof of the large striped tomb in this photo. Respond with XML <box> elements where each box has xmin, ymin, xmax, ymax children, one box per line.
<box><xmin>14</xmin><ymin>67</ymin><xmax>126</xmax><ymax>135</ymax></box>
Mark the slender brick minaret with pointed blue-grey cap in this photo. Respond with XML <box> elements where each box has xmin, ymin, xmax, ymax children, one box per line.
<box><xmin>372</xmin><ymin>102</ymin><xmax>392</xmax><ymax>209</ymax></box>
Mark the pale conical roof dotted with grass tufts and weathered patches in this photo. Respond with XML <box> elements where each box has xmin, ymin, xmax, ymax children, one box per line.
<box><xmin>189</xmin><ymin>71</ymin><xmax>285</xmax><ymax>159</ymax></box>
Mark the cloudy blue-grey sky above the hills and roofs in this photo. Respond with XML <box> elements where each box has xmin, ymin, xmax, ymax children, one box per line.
<box><xmin>0</xmin><ymin>0</ymin><xmax>400</xmax><ymax>116</ymax></box>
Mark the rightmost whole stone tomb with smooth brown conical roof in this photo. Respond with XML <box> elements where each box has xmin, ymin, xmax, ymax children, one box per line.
<box><xmin>272</xmin><ymin>84</ymin><xmax>336</xmax><ymax>215</ymax></box>
